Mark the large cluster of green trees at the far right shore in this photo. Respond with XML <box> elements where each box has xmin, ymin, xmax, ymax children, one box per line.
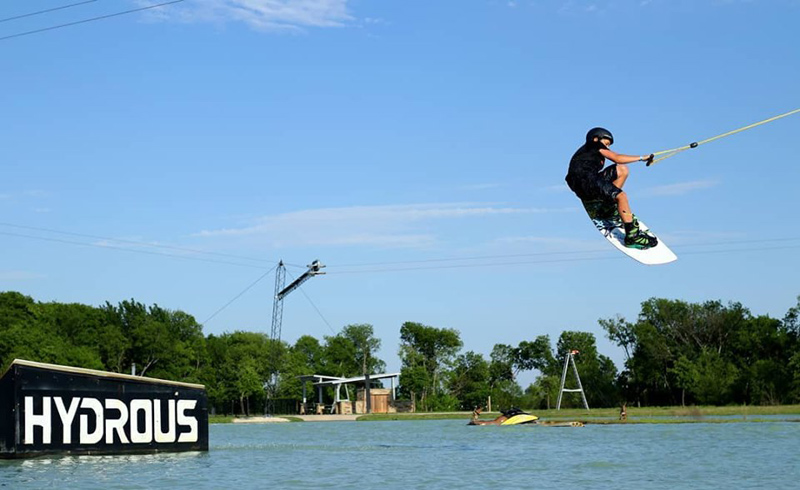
<box><xmin>600</xmin><ymin>298</ymin><xmax>800</xmax><ymax>405</ymax></box>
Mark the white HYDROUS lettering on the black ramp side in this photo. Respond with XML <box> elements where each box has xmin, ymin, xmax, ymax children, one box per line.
<box><xmin>21</xmin><ymin>396</ymin><xmax>199</xmax><ymax>445</ymax></box>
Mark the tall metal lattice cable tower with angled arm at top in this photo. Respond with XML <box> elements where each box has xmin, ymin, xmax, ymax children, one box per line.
<box><xmin>264</xmin><ymin>260</ymin><xmax>325</xmax><ymax>415</ymax></box>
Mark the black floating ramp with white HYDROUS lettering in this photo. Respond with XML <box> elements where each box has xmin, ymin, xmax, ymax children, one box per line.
<box><xmin>0</xmin><ymin>359</ymin><xmax>208</xmax><ymax>459</ymax></box>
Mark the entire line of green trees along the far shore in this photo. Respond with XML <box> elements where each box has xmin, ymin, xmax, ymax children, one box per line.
<box><xmin>0</xmin><ymin>292</ymin><xmax>800</xmax><ymax>414</ymax></box>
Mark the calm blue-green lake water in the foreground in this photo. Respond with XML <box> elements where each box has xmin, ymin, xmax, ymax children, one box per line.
<box><xmin>0</xmin><ymin>420</ymin><xmax>800</xmax><ymax>490</ymax></box>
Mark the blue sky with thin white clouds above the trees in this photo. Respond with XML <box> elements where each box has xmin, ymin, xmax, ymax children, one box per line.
<box><xmin>0</xmin><ymin>0</ymin><xmax>800</xmax><ymax>382</ymax></box>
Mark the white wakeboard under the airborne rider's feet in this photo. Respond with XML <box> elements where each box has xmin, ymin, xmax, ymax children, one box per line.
<box><xmin>583</xmin><ymin>201</ymin><xmax>678</xmax><ymax>265</ymax></box>
